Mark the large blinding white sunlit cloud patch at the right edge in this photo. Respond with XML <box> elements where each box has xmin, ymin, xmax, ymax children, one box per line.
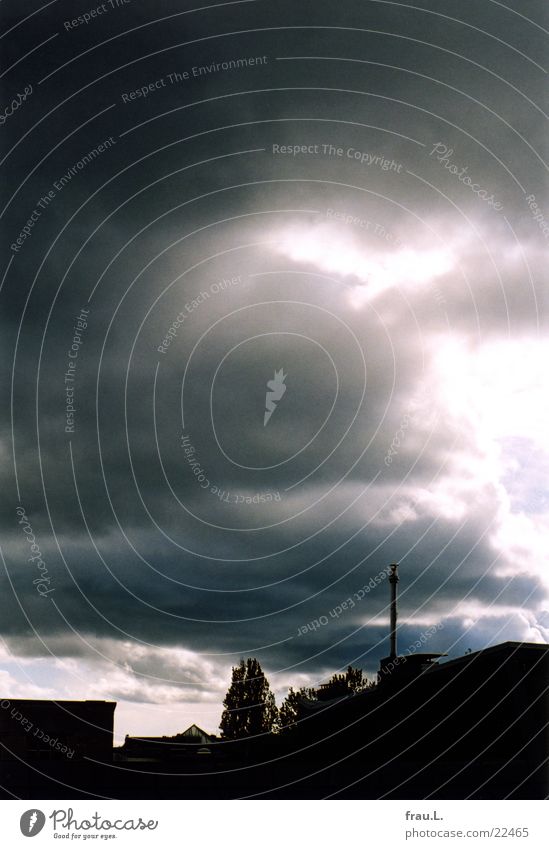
<box><xmin>433</xmin><ymin>339</ymin><xmax>549</xmax><ymax>586</ymax></box>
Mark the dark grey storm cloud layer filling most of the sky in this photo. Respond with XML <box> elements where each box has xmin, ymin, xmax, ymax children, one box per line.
<box><xmin>0</xmin><ymin>3</ymin><xmax>547</xmax><ymax>701</ymax></box>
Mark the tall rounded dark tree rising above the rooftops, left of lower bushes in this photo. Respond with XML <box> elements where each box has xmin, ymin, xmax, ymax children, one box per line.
<box><xmin>219</xmin><ymin>657</ymin><xmax>278</xmax><ymax>740</ymax></box>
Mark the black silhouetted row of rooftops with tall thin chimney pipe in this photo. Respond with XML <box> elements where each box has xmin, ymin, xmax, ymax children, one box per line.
<box><xmin>0</xmin><ymin>564</ymin><xmax>549</xmax><ymax>799</ymax></box>
